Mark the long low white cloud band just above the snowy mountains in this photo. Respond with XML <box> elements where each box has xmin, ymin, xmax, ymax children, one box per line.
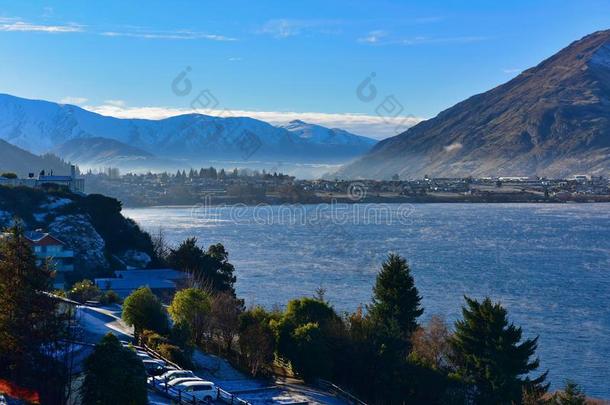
<box><xmin>84</xmin><ymin>103</ymin><xmax>422</xmax><ymax>139</ymax></box>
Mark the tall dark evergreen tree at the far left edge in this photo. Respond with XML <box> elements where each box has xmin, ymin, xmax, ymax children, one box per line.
<box><xmin>0</xmin><ymin>224</ymin><xmax>67</xmax><ymax>403</ymax></box>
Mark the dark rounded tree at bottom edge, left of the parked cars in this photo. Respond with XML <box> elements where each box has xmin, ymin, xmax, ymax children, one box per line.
<box><xmin>82</xmin><ymin>333</ymin><xmax>148</xmax><ymax>405</ymax></box>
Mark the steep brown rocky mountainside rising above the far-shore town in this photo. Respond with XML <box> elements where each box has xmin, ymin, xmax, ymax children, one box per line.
<box><xmin>339</xmin><ymin>30</ymin><xmax>610</xmax><ymax>178</ymax></box>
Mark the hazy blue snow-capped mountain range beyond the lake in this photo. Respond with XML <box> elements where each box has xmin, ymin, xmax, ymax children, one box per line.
<box><xmin>0</xmin><ymin>94</ymin><xmax>375</xmax><ymax>163</ymax></box>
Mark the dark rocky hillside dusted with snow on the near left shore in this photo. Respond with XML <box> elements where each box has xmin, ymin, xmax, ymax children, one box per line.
<box><xmin>0</xmin><ymin>186</ymin><xmax>156</xmax><ymax>279</ymax></box>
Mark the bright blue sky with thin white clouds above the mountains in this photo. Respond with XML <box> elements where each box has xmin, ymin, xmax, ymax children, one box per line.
<box><xmin>0</xmin><ymin>0</ymin><xmax>610</xmax><ymax>138</ymax></box>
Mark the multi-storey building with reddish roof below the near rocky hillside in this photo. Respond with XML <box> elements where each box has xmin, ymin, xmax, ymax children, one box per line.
<box><xmin>24</xmin><ymin>229</ymin><xmax>74</xmax><ymax>289</ymax></box>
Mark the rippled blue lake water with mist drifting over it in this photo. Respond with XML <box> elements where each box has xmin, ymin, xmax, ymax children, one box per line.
<box><xmin>125</xmin><ymin>204</ymin><xmax>610</xmax><ymax>398</ymax></box>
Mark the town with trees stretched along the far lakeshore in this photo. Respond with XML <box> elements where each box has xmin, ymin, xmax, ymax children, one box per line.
<box><xmin>77</xmin><ymin>167</ymin><xmax>610</xmax><ymax>207</ymax></box>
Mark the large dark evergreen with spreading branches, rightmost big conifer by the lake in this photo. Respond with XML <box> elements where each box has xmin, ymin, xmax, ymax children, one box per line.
<box><xmin>451</xmin><ymin>297</ymin><xmax>548</xmax><ymax>404</ymax></box>
